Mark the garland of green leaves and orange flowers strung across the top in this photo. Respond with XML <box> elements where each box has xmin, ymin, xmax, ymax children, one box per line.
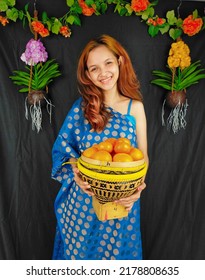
<box><xmin>0</xmin><ymin>0</ymin><xmax>205</xmax><ymax>40</ymax></box>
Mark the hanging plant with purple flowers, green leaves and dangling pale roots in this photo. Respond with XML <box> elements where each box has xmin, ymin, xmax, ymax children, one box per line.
<box><xmin>9</xmin><ymin>7</ymin><xmax>61</xmax><ymax>132</ymax></box>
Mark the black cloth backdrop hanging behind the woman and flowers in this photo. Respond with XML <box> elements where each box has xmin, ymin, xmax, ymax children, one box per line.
<box><xmin>0</xmin><ymin>0</ymin><xmax>205</xmax><ymax>260</ymax></box>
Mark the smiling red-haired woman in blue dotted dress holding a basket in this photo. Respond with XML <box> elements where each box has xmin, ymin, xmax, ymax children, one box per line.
<box><xmin>52</xmin><ymin>35</ymin><xmax>148</xmax><ymax>260</ymax></box>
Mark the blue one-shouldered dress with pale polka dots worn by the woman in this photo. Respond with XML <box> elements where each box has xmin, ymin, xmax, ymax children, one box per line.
<box><xmin>52</xmin><ymin>98</ymin><xmax>142</xmax><ymax>260</ymax></box>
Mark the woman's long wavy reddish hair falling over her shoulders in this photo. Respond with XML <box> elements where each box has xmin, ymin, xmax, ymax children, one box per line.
<box><xmin>77</xmin><ymin>35</ymin><xmax>142</xmax><ymax>131</ymax></box>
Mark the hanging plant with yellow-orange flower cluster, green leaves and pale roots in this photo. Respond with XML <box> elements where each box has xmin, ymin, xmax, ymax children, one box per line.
<box><xmin>151</xmin><ymin>39</ymin><xmax>205</xmax><ymax>133</ymax></box>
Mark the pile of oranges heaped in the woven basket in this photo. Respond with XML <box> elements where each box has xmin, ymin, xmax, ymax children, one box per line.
<box><xmin>83</xmin><ymin>137</ymin><xmax>144</xmax><ymax>162</ymax></box>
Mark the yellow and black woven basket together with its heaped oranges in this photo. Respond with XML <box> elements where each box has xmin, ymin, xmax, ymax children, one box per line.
<box><xmin>77</xmin><ymin>138</ymin><xmax>147</xmax><ymax>204</ymax></box>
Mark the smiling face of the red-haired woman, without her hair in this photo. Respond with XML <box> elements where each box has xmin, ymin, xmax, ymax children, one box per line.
<box><xmin>87</xmin><ymin>45</ymin><xmax>119</xmax><ymax>91</ymax></box>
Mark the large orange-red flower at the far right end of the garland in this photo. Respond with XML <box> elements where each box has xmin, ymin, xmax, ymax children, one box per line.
<box><xmin>182</xmin><ymin>15</ymin><xmax>203</xmax><ymax>36</ymax></box>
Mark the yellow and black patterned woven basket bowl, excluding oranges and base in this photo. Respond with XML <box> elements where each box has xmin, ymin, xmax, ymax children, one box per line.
<box><xmin>78</xmin><ymin>156</ymin><xmax>147</xmax><ymax>204</ymax></box>
